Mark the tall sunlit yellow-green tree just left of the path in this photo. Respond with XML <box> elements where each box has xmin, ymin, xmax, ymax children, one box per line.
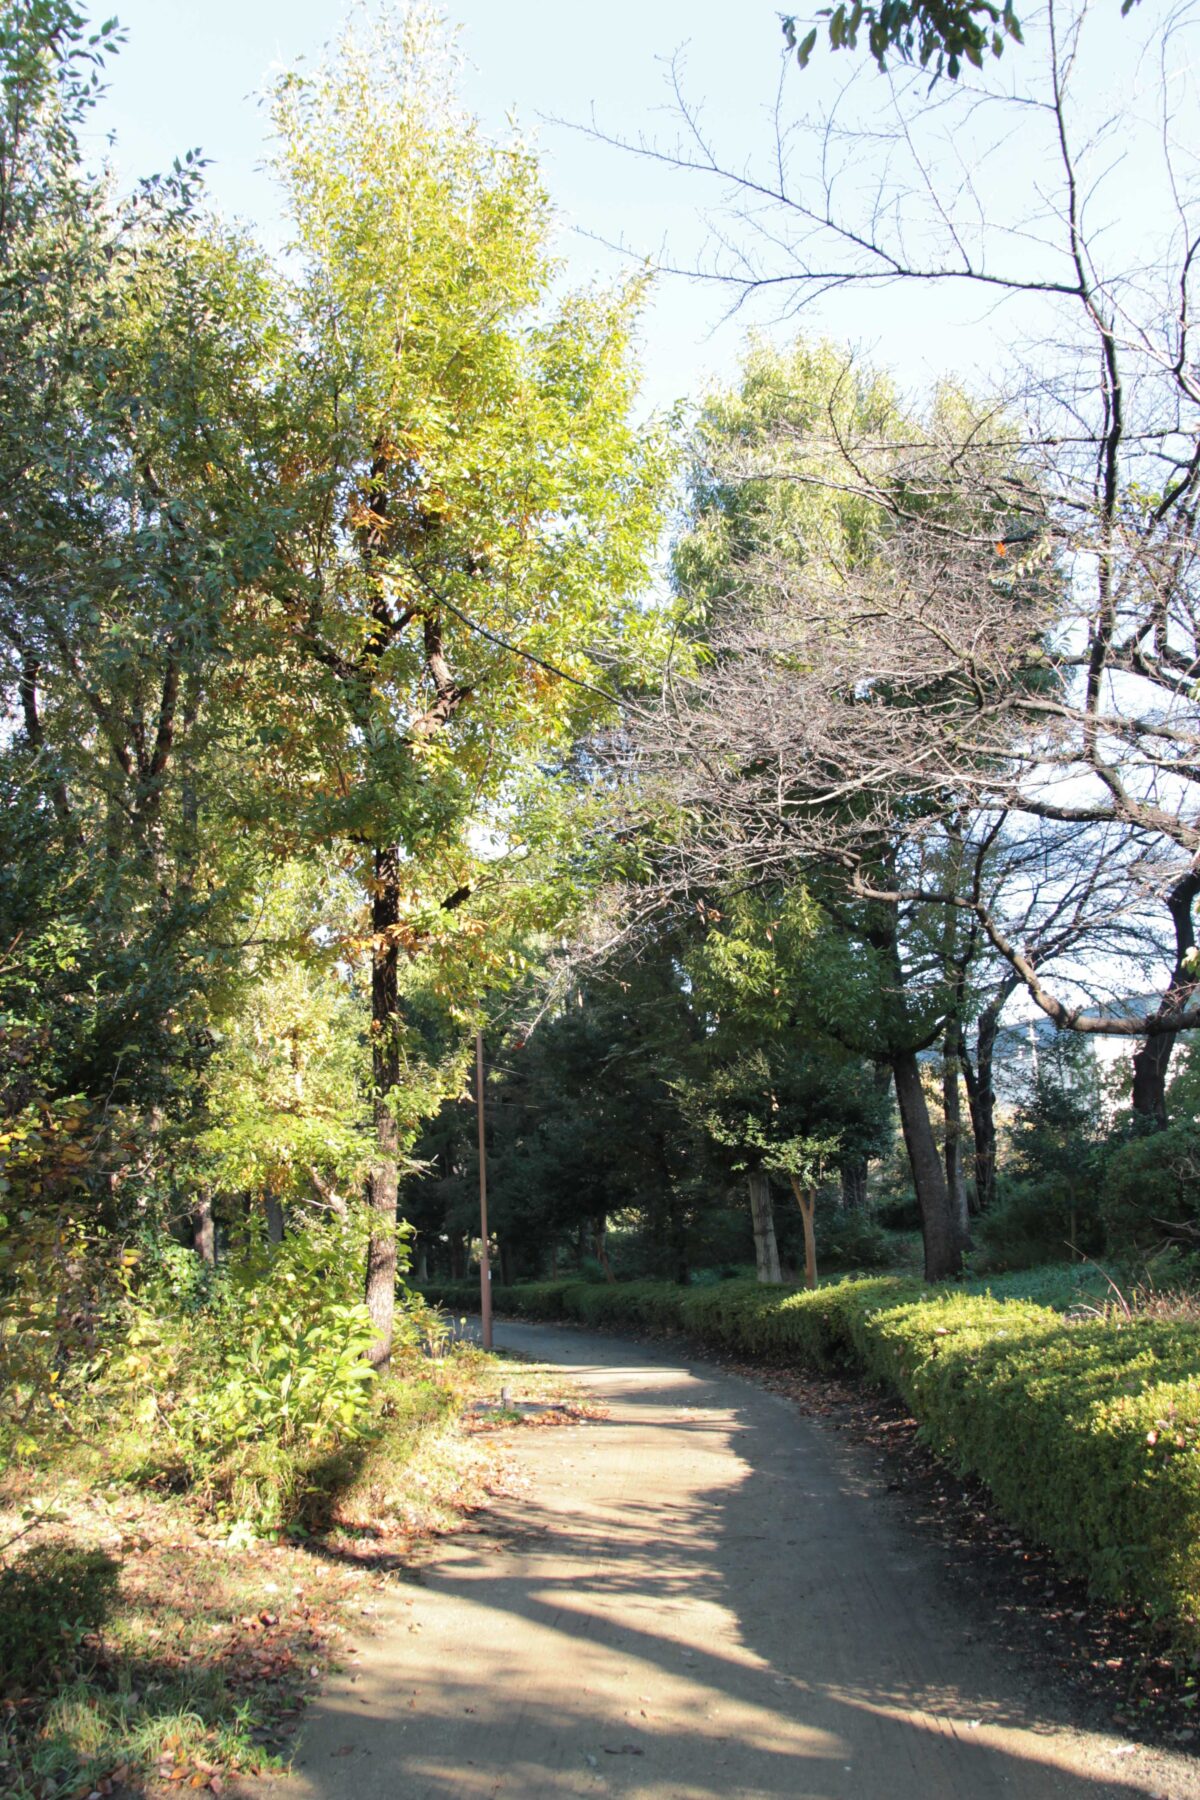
<box><xmin>272</xmin><ymin>14</ymin><xmax>666</xmax><ymax>1361</ymax></box>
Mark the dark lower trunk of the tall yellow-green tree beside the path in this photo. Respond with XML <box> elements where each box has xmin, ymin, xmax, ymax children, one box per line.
<box><xmin>365</xmin><ymin>846</ymin><xmax>399</xmax><ymax>1368</ymax></box>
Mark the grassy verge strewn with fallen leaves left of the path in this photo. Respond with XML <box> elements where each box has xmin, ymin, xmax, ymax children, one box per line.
<box><xmin>0</xmin><ymin>1346</ymin><xmax>558</xmax><ymax>1800</ymax></box>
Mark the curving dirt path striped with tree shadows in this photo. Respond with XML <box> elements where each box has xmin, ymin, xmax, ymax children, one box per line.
<box><xmin>275</xmin><ymin>1325</ymin><xmax>1200</xmax><ymax>1800</ymax></box>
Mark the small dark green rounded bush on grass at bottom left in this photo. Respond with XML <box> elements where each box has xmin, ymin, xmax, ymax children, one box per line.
<box><xmin>0</xmin><ymin>1544</ymin><xmax>121</xmax><ymax>1692</ymax></box>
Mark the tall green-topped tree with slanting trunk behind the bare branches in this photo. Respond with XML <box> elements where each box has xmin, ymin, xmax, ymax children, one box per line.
<box><xmin>618</xmin><ymin>344</ymin><xmax>1036</xmax><ymax>1278</ymax></box>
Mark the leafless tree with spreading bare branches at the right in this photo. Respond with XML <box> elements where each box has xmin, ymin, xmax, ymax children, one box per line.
<box><xmin>586</xmin><ymin>0</ymin><xmax>1200</xmax><ymax>1121</ymax></box>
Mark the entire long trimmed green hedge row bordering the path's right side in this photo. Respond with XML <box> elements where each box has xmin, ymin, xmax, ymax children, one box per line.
<box><xmin>425</xmin><ymin>1276</ymin><xmax>1200</xmax><ymax>1645</ymax></box>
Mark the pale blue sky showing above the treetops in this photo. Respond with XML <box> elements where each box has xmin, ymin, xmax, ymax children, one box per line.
<box><xmin>84</xmin><ymin>0</ymin><xmax>1194</xmax><ymax>417</ymax></box>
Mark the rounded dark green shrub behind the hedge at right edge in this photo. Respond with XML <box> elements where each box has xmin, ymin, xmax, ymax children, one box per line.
<box><xmin>1099</xmin><ymin>1123</ymin><xmax>1200</xmax><ymax>1256</ymax></box>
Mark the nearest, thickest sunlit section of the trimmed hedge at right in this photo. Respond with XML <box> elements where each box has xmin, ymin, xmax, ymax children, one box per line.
<box><xmin>862</xmin><ymin>1294</ymin><xmax>1200</xmax><ymax>1620</ymax></box>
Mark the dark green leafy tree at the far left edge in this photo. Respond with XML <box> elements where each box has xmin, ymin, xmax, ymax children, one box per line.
<box><xmin>0</xmin><ymin>0</ymin><xmax>287</xmax><ymax>1118</ymax></box>
